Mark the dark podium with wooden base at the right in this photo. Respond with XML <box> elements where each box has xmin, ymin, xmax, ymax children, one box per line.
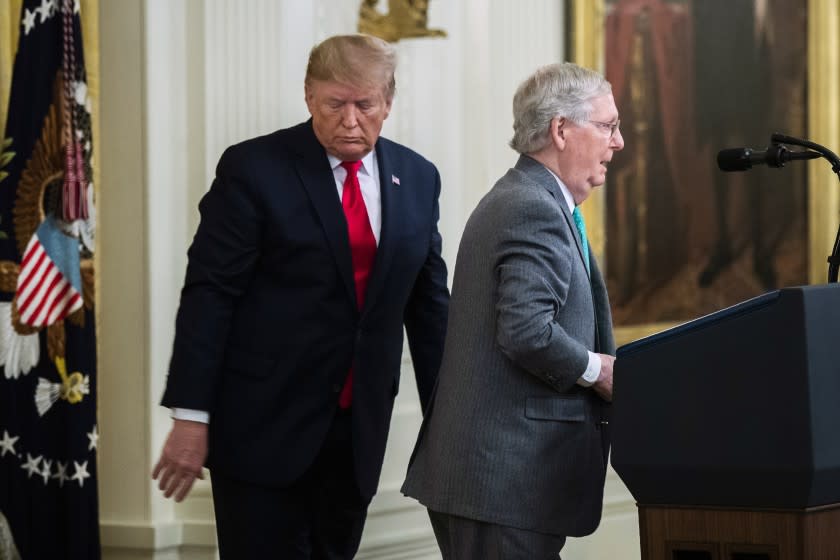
<box><xmin>611</xmin><ymin>284</ymin><xmax>840</xmax><ymax>560</ymax></box>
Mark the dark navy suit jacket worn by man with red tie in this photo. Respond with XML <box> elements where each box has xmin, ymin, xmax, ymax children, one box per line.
<box><xmin>162</xmin><ymin>121</ymin><xmax>449</xmax><ymax>496</ymax></box>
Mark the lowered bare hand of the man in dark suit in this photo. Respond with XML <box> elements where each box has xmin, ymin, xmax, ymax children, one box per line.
<box><xmin>152</xmin><ymin>420</ymin><xmax>207</xmax><ymax>502</ymax></box>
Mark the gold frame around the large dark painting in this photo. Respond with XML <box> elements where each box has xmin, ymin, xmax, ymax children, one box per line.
<box><xmin>568</xmin><ymin>0</ymin><xmax>840</xmax><ymax>344</ymax></box>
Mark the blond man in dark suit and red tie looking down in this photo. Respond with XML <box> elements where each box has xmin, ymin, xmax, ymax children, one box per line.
<box><xmin>153</xmin><ymin>35</ymin><xmax>449</xmax><ymax>559</ymax></box>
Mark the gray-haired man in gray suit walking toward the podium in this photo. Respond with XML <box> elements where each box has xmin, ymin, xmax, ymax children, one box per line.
<box><xmin>402</xmin><ymin>63</ymin><xmax>624</xmax><ymax>560</ymax></box>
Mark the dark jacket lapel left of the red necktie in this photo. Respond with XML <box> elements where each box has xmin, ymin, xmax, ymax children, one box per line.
<box><xmin>294</xmin><ymin>119</ymin><xmax>357</xmax><ymax>307</ymax></box>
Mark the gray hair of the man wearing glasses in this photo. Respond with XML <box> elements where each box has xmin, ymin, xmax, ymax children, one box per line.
<box><xmin>510</xmin><ymin>62</ymin><xmax>612</xmax><ymax>154</ymax></box>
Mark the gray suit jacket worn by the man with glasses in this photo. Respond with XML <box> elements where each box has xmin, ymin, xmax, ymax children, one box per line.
<box><xmin>402</xmin><ymin>156</ymin><xmax>615</xmax><ymax>536</ymax></box>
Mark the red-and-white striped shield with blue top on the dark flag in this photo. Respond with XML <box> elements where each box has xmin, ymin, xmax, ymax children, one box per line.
<box><xmin>15</xmin><ymin>216</ymin><xmax>84</xmax><ymax>327</ymax></box>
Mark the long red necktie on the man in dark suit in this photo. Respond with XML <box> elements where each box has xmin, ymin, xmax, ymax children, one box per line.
<box><xmin>338</xmin><ymin>161</ymin><xmax>376</xmax><ymax>408</ymax></box>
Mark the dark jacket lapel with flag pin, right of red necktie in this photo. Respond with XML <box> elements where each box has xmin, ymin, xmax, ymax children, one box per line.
<box><xmin>362</xmin><ymin>140</ymin><xmax>398</xmax><ymax>314</ymax></box>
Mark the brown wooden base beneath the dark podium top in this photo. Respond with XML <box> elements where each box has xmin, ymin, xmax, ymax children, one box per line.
<box><xmin>639</xmin><ymin>504</ymin><xmax>840</xmax><ymax>560</ymax></box>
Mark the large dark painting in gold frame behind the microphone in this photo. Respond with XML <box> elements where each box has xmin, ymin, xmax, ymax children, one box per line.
<box><xmin>567</xmin><ymin>0</ymin><xmax>840</xmax><ymax>343</ymax></box>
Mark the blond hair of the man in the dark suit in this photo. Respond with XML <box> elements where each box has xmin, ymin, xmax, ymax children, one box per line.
<box><xmin>304</xmin><ymin>34</ymin><xmax>397</xmax><ymax>100</ymax></box>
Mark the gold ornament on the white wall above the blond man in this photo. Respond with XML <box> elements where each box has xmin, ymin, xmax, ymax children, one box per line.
<box><xmin>358</xmin><ymin>0</ymin><xmax>446</xmax><ymax>43</ymax></box>
